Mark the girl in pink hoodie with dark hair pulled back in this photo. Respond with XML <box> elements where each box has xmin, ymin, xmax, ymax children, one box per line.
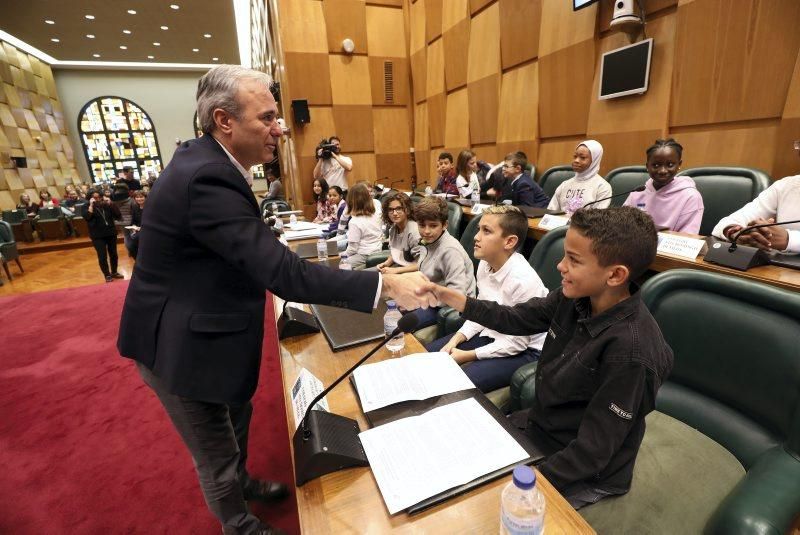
<box><xmin>625</xmin><ymin>138</ymin><xmax>703</xmax><ymax>234</ymax></box>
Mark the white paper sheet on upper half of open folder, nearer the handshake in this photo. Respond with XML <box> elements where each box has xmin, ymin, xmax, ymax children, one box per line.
<box><xmin>353</xmin><ymin>353</ymin><xmax>475</xmax><ymax>412</ymax></box>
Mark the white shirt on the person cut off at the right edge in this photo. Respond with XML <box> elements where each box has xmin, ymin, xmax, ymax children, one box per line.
<box><xmin>711</xmin><ymin>175</ymin><xmax>800</xmax><ymax>253</ymax></box>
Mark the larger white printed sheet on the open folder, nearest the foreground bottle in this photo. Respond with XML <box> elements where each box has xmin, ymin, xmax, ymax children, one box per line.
<box><xmin>359</xmin><ymin>398</ymin><xmax>528</xmax><ymax>514</ymax></box>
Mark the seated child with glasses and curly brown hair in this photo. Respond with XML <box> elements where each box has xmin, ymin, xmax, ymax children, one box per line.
<box><xmin>377</xmin><ymin>192</ymin><xmax>421</xmax><ymax>273</ymax></box>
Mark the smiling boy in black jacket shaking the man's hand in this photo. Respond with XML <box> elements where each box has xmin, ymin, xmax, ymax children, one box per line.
<box><xmin>418</xmin><ymin>207</ymin><xmax>672</xmax><ymax>509</ymax></box>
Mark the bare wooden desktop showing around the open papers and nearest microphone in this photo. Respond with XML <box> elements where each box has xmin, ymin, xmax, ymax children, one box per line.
<box><xmin>275</xmin><ymin>304</ymin><xmax>594</xmax><ymax>535</ymax></box>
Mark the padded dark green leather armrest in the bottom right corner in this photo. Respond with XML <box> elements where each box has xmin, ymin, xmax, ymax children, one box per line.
<box><xmin>704</xmin><ymin>446</ymin><xmax>800</xmax><ymax>535</ymax></box>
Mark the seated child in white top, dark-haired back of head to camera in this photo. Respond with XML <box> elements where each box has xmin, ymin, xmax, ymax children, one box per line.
<box><xmin>345</xmin><ymin>184</ymin><xmax>383</xmax><ymax>269</ymax></box>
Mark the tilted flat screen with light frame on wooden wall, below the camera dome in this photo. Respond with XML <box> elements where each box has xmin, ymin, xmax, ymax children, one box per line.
<box><xmin>599</xmin><ymin>38</ymin><xmax>653</xmax><ymax>100</ymax></box>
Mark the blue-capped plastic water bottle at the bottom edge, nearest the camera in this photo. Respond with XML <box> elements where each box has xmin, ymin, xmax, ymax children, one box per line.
<box><xmin>500</xmin><ymin>466</ymin><xmax>545</xmax><ymax>535</ymax></box>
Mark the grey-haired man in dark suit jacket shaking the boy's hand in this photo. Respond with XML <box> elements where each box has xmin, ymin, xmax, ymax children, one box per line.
<box><xmin>117</xmin><ymin>65</ymin><xmax>435</xmax><ymax>534</ymax></box>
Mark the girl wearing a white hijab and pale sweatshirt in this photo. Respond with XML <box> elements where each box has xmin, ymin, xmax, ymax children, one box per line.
<box><xmin>547</xmin><ymin>139</ymin><xmax>611</xmax><ymax>215</ymax></box>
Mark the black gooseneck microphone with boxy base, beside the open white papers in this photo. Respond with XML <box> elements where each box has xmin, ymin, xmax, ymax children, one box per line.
<box><xmin>292</xmin><ymin>314</ymin><xmax>419</xmax><ymax>487</ymax></box>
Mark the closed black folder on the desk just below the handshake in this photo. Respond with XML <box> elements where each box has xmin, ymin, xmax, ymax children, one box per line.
<box><xmin>311</xmin><ymin>300</ymin><xmax>386</xmax><ymax>351</ymax></box>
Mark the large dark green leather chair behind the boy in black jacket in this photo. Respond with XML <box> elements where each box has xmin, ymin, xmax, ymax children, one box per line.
<box><xmin>512</xmin><ymin>270</ymin><xmax>800</xmax><ymax>535</ymax></box>
